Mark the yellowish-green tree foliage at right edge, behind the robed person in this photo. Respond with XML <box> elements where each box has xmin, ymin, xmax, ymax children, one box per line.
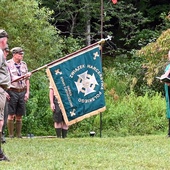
<box><xmin>138</xmin><ymin>29</ymin><xmax>170</xmax><ymax>85</ymax></box>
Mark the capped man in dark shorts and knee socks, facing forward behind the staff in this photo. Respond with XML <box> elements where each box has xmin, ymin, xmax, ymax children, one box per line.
<box><xmin>7</xmin><ymin>47</ymin><xmax>30</xmax><ymax>138</ymax></box>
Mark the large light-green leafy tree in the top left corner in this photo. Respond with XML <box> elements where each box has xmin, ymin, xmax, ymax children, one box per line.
<box><xmin>0</xmin><ymin>0</ymin><xmax>62</xmax><ymax>69</ymax></box>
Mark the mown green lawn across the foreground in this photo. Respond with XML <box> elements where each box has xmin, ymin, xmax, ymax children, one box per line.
<box><xmin>0</xmin><ymin>135</ymin><xmax>170</xmax><ymax>170</ymax></box>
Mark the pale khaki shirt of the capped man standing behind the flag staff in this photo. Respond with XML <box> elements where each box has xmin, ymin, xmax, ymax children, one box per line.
<box><xmin>7</xmin><ymin>59</ymin><xmax>28</xmax><ymax>89</ymax></box>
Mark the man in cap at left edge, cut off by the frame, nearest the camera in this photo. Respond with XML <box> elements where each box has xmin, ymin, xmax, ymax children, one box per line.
<box><xmin>0</xmin><ymin>29</ymin><xmax>11</xmax><ymax>161</ymax></box>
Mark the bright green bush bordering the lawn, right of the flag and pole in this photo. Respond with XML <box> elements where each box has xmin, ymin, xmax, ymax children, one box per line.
<box><xmin>103</xmin><ymin>93</ymin><xmax>166</xmax><ymax>136</ymax></box>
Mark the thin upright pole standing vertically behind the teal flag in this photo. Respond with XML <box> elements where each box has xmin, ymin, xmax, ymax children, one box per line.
<box><xmin>100</xmin><ymin>0</ymin><xmax>104</xmax><ymax>137</ymax></box>
